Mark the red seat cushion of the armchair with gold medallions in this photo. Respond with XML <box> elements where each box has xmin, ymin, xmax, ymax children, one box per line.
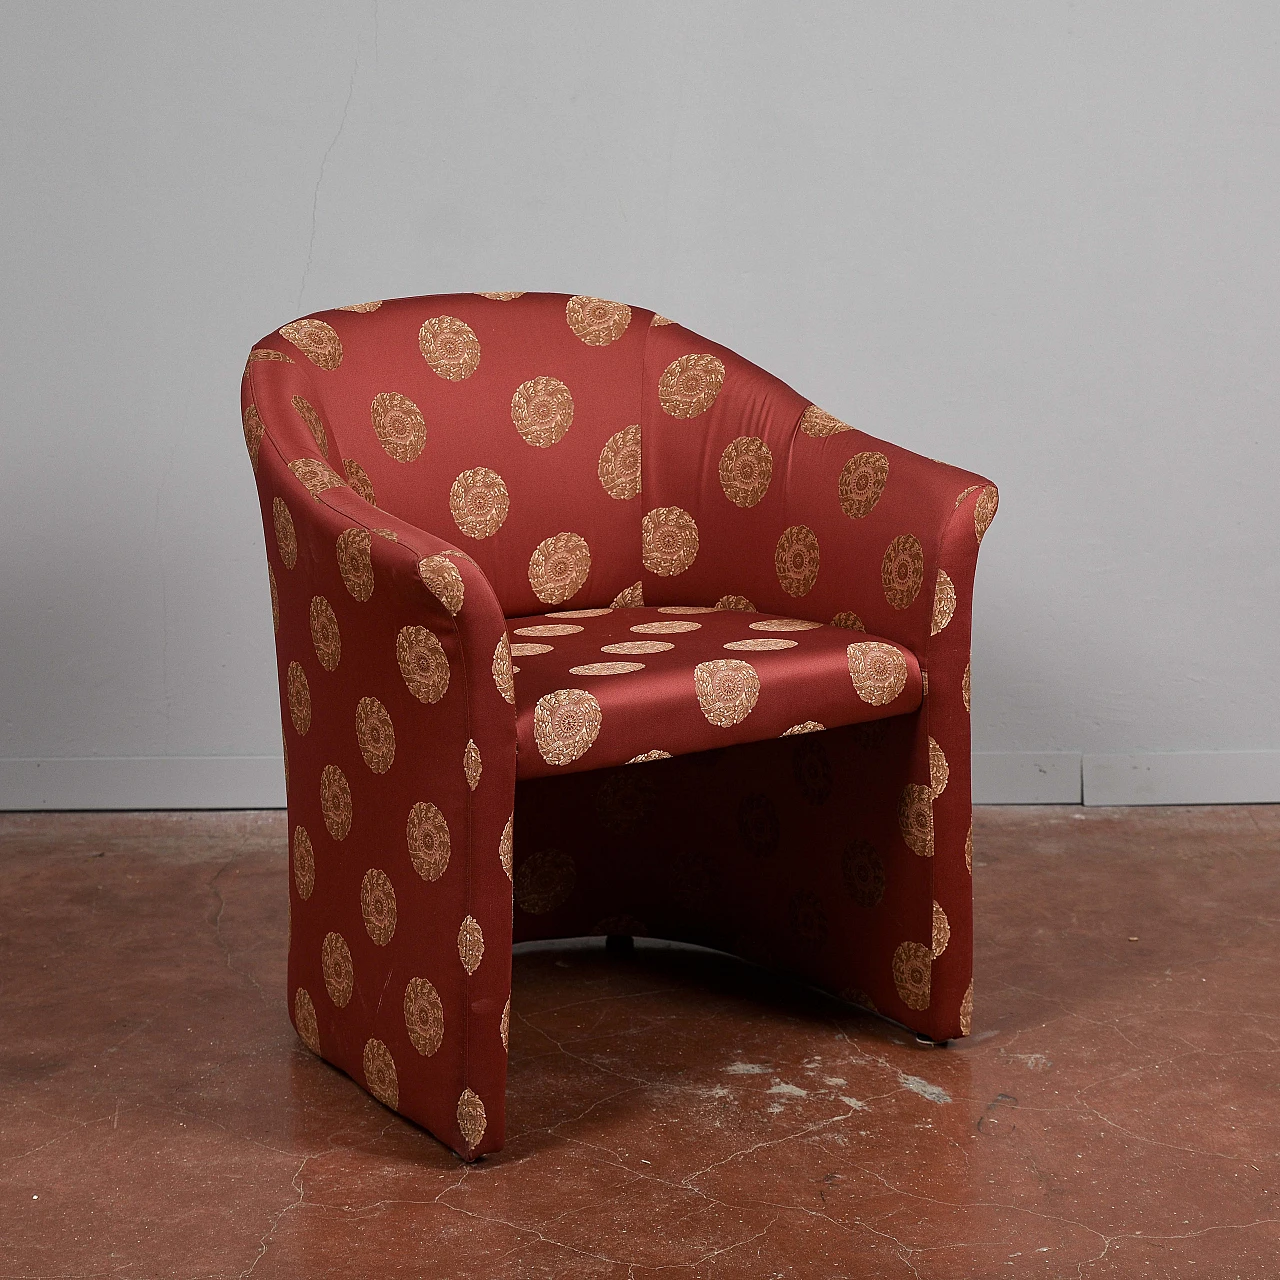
<box><xmin>507</xmin><ymin>605</ymin><xmax>922</xmax><ymax>778</ymax></box>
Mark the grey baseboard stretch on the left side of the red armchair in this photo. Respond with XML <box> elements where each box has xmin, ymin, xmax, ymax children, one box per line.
<box><xmin>0</xmin><ymin>755</ymin><xmax>284</xmax><ymax>812</ymax></box>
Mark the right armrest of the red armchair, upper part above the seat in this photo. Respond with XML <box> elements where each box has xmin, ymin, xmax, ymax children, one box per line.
<box><xmin>643</xmin><ymin>318</ymin><xmax>997</xmax><ymax>666</ymax></box>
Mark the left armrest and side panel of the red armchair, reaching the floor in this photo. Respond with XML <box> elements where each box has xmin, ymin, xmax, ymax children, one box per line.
<box><xmin>244</xmin><ymin>362</ymin><xmax>516</xmax><ymax>1158</ymax></box>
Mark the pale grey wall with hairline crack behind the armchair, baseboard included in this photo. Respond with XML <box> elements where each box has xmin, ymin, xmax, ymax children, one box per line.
<box><xmin>0</xmin><ymin>0</ymin><xmax>1280</xmax><ymax>808</ymax></box>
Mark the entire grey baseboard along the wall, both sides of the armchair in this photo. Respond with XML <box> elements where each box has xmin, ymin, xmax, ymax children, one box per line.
<box><xmin>0</xmin><ymin>751</ymin><xmax>1280</xmax><ymax>812</ymax></box>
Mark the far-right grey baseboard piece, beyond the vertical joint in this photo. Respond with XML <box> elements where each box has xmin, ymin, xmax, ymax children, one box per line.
<box><xmin>1084</xmin><ymin>751</ymin><xmax>1280</xmax><ymax>805</ymax></box>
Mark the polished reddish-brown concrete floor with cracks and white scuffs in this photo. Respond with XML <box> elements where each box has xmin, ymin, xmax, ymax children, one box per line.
<box><xmin>0</xmin><ymin>806</ymin><xmax>1280</xmax><ymax>1280</ymax></box>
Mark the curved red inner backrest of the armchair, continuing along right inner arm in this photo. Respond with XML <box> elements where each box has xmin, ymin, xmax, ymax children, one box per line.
<box><xmin>248</xmin><ymin>293</ymin><xmax>977</xmax><ymax>653</ymax></box>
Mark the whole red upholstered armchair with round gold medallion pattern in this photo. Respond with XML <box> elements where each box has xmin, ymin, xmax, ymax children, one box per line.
<box><xmin>243</xmin><ymin>293</ymin><xmax>996</xmax><ymax>1158</ymax></box>
